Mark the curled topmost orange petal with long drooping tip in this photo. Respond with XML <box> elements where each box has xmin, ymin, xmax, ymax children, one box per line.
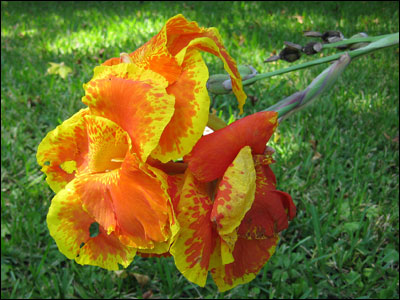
<box><xmin>103</xmin><ymin>14</ymin><xmax>246</xmax><ymax>113</ymax></box>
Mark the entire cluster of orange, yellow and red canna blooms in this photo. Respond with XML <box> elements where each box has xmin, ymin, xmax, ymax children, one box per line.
<box><xmin>37</xmin><ymin>15</ymin><xmax>295</xmax><ymax>291</ymax></box>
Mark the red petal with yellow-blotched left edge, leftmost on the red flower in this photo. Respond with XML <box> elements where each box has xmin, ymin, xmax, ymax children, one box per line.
<box><xmin>170</xmin><ymin>171</ymin><xmax>218</xmax><ymax>286</ymax></box>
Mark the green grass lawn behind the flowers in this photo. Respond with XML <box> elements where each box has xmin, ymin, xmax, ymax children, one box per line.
<box><xmin>1</xmin><ymin>1</ymin><xmax>399</xmax><ymax>298</ymax></box>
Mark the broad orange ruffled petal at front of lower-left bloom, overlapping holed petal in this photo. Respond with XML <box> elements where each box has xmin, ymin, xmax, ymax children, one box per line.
<box><xmin>52</xmin><ymin>153</ymin><xmax>173</xmax><ymax>253</ymax></box>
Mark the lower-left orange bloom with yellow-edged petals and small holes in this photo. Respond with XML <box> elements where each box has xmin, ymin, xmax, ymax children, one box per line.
<box><xmin>37</xmin><ymin>108</ymin><xmax>177</xmax><ymax>270</ymax></box>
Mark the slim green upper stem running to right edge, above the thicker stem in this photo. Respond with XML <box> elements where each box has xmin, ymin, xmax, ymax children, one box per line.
<box><xmin>242</xmin><ymin>32</ymin><xmax>399</xmax><ymax>86</ymax></box>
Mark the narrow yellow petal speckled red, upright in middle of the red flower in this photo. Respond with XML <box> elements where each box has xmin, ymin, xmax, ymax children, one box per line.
<box><xmin>211</xmin><ymin>146</ymin><xmax>256</xmax><ymax>264</ymax></box>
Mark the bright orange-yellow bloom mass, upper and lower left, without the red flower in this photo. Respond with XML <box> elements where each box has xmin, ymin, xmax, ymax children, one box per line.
<box><xmin>37</xmin><ymin>15</ymin><xmax>250</xmax><ymax>270</ymax></box>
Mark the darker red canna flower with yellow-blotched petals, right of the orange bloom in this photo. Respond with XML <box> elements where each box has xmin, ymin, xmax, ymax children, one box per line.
<box><xmin>168</xmin><ymin>112</ymin><xmax>296</xmax><ymax>292</ymax></box>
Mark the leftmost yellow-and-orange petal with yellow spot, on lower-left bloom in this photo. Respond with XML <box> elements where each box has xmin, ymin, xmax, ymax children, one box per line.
<box><xmin>36</xmin><ymin>109</ymin><xmax>89</xmax><ymax>193</ymax></box>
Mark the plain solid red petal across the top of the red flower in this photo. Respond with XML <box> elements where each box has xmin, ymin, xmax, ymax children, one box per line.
<box><xmin>184</xmin><ymin>111</ymin><xmax>277</xmax><ymax>181</ymax></box>
